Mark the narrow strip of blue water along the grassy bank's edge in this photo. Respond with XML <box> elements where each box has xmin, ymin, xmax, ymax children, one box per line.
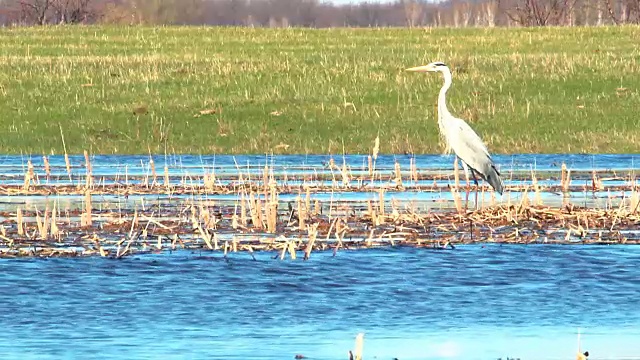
<box><xmin>0</xmin><ymin>154</ymin><xmax>640</xmax><ymax>177</ymax></box>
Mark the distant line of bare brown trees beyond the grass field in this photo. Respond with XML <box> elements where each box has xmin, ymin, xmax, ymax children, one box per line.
<box><xmin>0</xmin><ymin>0</ymin><xmax>640</xmax><ymax>28</ymax></box>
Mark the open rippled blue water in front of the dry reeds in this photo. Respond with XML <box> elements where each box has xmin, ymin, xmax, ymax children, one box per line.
<box><xmin>0</xmin><ymin>245</ymin><xmax>640</xmax><ymax>360</ymax></box>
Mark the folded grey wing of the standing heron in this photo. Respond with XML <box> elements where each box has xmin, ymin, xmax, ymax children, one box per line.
<box><xmin>447</xmin><ymin>118</ymin><xmax>504</xmax><ymax>194</ymax></box>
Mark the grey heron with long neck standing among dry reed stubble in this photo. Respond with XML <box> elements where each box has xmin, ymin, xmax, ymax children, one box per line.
<box><xmin>406</xmin><ymin>61</ymin><xmax>504</xmax><ymax>207</ymax></box>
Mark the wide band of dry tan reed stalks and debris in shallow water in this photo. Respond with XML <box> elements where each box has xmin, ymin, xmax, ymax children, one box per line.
<box><xmin>0</xmin><ymin>153</ymin><xmax>640</xmax><ymax>259</ymax></box>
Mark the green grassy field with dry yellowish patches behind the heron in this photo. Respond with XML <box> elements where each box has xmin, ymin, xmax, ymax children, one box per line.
<box><xmin>0</xmin><ymin>26</ymin><xmax>640</xmax><ymax>154</ymax></box>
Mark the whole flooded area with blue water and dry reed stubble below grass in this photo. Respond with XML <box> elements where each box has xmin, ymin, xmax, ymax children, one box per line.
<box><xmin>0</xmin><ymin>155</ymin><xmax>640</xmax><ymax>360</ymax></box>
